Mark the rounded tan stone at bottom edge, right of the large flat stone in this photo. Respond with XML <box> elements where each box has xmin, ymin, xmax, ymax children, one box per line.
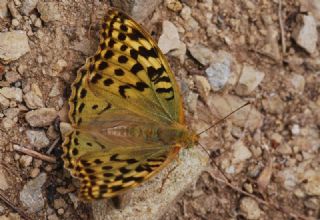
<box><xmin>240</xmin><ymin>197</ymin><xmax>262</xmax><ymax>220</ymax></box>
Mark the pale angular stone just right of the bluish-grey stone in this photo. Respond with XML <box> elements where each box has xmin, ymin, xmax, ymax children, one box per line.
<box><xmin>235</xmin><ymin>64</ymin><xmax>265</xmax><ymax>96</ymax></box>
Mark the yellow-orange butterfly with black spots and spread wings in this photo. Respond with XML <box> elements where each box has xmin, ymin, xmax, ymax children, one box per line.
<box><xmin>62</xmin><ymin>9</ymin><xmax>199</xmax><ymax>201</ymax></box>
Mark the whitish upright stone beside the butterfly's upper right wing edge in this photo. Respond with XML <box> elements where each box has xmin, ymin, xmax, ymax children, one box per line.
<box><xmin>158</xmin><ymin>20</ymin><xmax>180</xmax><ymax>54</ymax></box>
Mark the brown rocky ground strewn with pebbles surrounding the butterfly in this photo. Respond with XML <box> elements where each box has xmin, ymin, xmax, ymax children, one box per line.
<box><xmin>0</xmin><ymin>0</ymin><xmax>320</xmax><ymax>220</ymax></box>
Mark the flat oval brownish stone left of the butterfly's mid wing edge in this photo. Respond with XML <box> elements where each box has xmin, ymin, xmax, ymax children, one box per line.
<box><xmin>25</xmin><ymin>108</ymin><xmax>57</xmax><ymax>127</ymax></box>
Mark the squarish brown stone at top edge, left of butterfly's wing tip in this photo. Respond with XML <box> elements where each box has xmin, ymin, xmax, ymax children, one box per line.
<box><xmin>37</xmin><ymin>1</ymin><xmax>61</xmax><ymax>22</ymax></box>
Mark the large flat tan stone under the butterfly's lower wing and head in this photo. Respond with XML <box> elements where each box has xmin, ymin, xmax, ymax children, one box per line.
<box><xmin>92</xmin><ymin>147</ymin><xmax>208</xmax><ymax>220</ymax></box>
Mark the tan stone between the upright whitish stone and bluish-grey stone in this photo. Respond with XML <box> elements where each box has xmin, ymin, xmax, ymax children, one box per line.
<box><xmin>188</xmin><ymin>44</ymin><xmax>214</xmax><ymax>66</ymax></box>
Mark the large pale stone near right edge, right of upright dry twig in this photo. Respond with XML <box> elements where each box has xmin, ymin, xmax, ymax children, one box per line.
<box><xmin>292</xmin><ymin>15</ymin><xmax>318</xmax><ymax>54</ymax></box>
